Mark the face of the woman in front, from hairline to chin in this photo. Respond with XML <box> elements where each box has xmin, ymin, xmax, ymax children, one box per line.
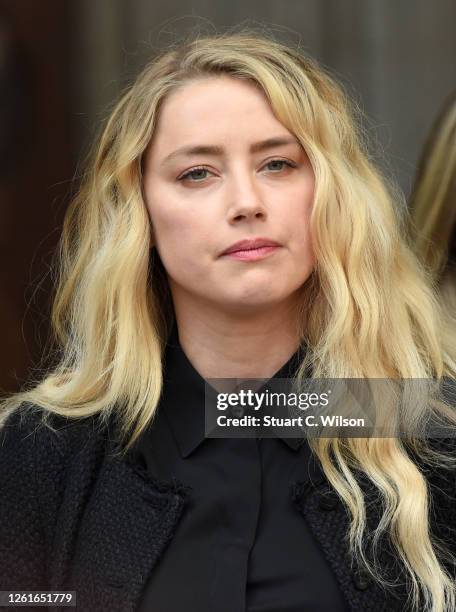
<box><xmin>143</xmin><ymin>75</ymin><xmax>314</xmax><ymax>313</ymax></box>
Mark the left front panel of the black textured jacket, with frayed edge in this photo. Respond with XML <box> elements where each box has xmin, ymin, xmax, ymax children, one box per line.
<box><xmin>52</xmin><ymin>432</ymin><xmax>188</xmax><ymax>612</ymax></box>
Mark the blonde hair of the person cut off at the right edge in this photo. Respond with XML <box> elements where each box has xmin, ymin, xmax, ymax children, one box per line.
<box><xmin>409</xmin><ymin>91</ymin><xmax>456</xmax><ymax>332</ymax></box>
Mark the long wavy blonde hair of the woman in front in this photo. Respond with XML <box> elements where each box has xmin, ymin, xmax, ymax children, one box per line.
<box><xmin>2</xmin><ymin>28</ymin><xmax>456</xmax><ymax>612</ymax></box>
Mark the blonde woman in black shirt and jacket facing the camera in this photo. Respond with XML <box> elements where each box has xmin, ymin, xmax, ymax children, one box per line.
<box><xmin>0</xmin><ymin>31</ymin><xmax>456</xmax><ymax>612</ymax></box>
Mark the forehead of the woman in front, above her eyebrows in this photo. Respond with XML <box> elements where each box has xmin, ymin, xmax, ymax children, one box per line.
<box><xmin>151</xmin><ymin>75</ymin><xmax>289</xmax><ymax>149</ymax></box>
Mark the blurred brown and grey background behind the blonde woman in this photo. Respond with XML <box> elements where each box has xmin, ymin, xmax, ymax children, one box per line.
<box><xmin>0</xmin><ymin>0</ymin><xmax>456</xmax><ymax>392</ymax></box>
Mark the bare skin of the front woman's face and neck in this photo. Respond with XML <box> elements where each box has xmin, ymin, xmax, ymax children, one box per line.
<box><xmin>144</xmin><ymin>75</ymin><xmax>314</xmax><ymax>378</ymax></box>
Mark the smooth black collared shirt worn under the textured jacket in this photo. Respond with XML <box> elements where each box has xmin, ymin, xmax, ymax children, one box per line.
<box><xmin>134</xmin><ymin>329</ymin><xmax>347</xmax><ymax>612</ymax></box>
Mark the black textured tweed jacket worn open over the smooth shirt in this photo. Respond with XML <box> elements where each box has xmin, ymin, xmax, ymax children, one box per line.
<box><xmin>0</xmin><ymin>407</ymin><xmax>456</xmax><ymax>612</ymax></box>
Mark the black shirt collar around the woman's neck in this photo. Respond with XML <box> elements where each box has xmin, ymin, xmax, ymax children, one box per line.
<box><xmin>162</xmin><ymin>324</ymin><xmax>312</xmax><ymax>458</ymax></box>
